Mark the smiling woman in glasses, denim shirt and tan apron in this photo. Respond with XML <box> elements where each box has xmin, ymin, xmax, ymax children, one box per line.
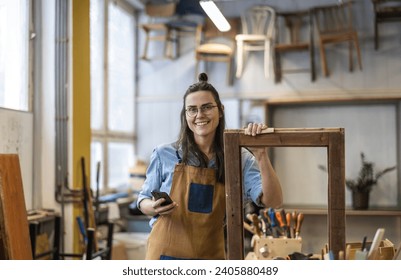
<box><xmin>137</xmin><ymin>73</ymin><xmax>282</xmax><ymax>260</ymax></box>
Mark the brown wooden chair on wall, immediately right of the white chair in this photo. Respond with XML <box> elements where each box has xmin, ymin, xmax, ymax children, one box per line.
<box><xmin>273</xmin><ymin>11</ymin><xmax>316</xmax><ymax>83</ymax></box>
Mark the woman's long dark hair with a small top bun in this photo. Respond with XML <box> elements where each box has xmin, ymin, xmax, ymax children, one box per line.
<box><xmin>177</xmin><ymin>73</ymin><xmax>225</xmax><ymax>183</ymax></box>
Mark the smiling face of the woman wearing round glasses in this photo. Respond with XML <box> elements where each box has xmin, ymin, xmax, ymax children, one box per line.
<box><xmin>185</xmin><ymin>91</ymin><xmax>220</xmax><ymax>140</ymax></box>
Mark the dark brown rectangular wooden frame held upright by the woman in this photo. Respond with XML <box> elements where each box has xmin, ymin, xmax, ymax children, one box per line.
<box><xmin>224</xmin><ymin>128</ymin><xmax>345</xmax><ymax>259</ymax></box>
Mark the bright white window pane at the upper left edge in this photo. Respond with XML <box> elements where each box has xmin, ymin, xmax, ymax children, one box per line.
<box><xmin>0</xmin><ymin>0</ymin><xmax>30</xmax><ymax>111</ymax></box>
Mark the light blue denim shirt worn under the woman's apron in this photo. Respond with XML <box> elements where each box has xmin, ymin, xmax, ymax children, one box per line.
<box><xmin>137</xmin><ymin>143</ymin><xmax>263</xmax><ymax>226</ymax></box>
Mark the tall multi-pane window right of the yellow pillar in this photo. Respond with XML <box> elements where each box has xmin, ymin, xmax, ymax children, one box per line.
<box><xmin>90</xmin><ymin>0</ymin><xmax>136</xmax><ymax>193</ymax></box>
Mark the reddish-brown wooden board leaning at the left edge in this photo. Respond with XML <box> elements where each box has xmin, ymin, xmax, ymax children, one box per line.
<box><xmin>0</xmin><ymin>154</ymin><xmax>32</xmax><ymax>260</ymax></box>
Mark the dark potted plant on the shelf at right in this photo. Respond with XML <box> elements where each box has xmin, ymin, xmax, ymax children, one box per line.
<box><xmin>345</xmin><ymin>152</ymin><xmax>396</xmax><ymax>210</ymax></box>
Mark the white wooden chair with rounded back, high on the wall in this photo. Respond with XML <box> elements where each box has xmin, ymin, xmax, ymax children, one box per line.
<box><xmin>235</xmin><ymin>5</ymin><xmax>276</xmax><ymax>78</ymax></box>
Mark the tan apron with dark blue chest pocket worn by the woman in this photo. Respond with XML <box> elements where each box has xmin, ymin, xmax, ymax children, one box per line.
<box><xmin>146</xmin><ymin>163</ymin><xmax>226</xmax><ymax>260</ymax></box>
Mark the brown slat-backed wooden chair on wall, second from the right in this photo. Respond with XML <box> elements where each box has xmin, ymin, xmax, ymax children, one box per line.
<box><xmin>312</xmin><ymin>1</ymin><xmax>362</xmax><ymax>77</ymax></box>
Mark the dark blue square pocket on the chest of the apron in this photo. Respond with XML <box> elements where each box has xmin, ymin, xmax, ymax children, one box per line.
<box><xmin>188</xmin><ymin>183</ymin><xmax>214</xmax><ymax>213</ymax></box>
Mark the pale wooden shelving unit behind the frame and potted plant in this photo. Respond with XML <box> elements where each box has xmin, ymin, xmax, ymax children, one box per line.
<box><xmin>263</xmin><ymin>97</ymin><xmax>401</xmax><ymax>253</ymax></box>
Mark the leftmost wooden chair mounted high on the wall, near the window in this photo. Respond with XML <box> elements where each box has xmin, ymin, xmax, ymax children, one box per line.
<box><xmin>139</xmin><ymin>1</ymin><xmax>177</xmax><ymax>60</ymax></box>
